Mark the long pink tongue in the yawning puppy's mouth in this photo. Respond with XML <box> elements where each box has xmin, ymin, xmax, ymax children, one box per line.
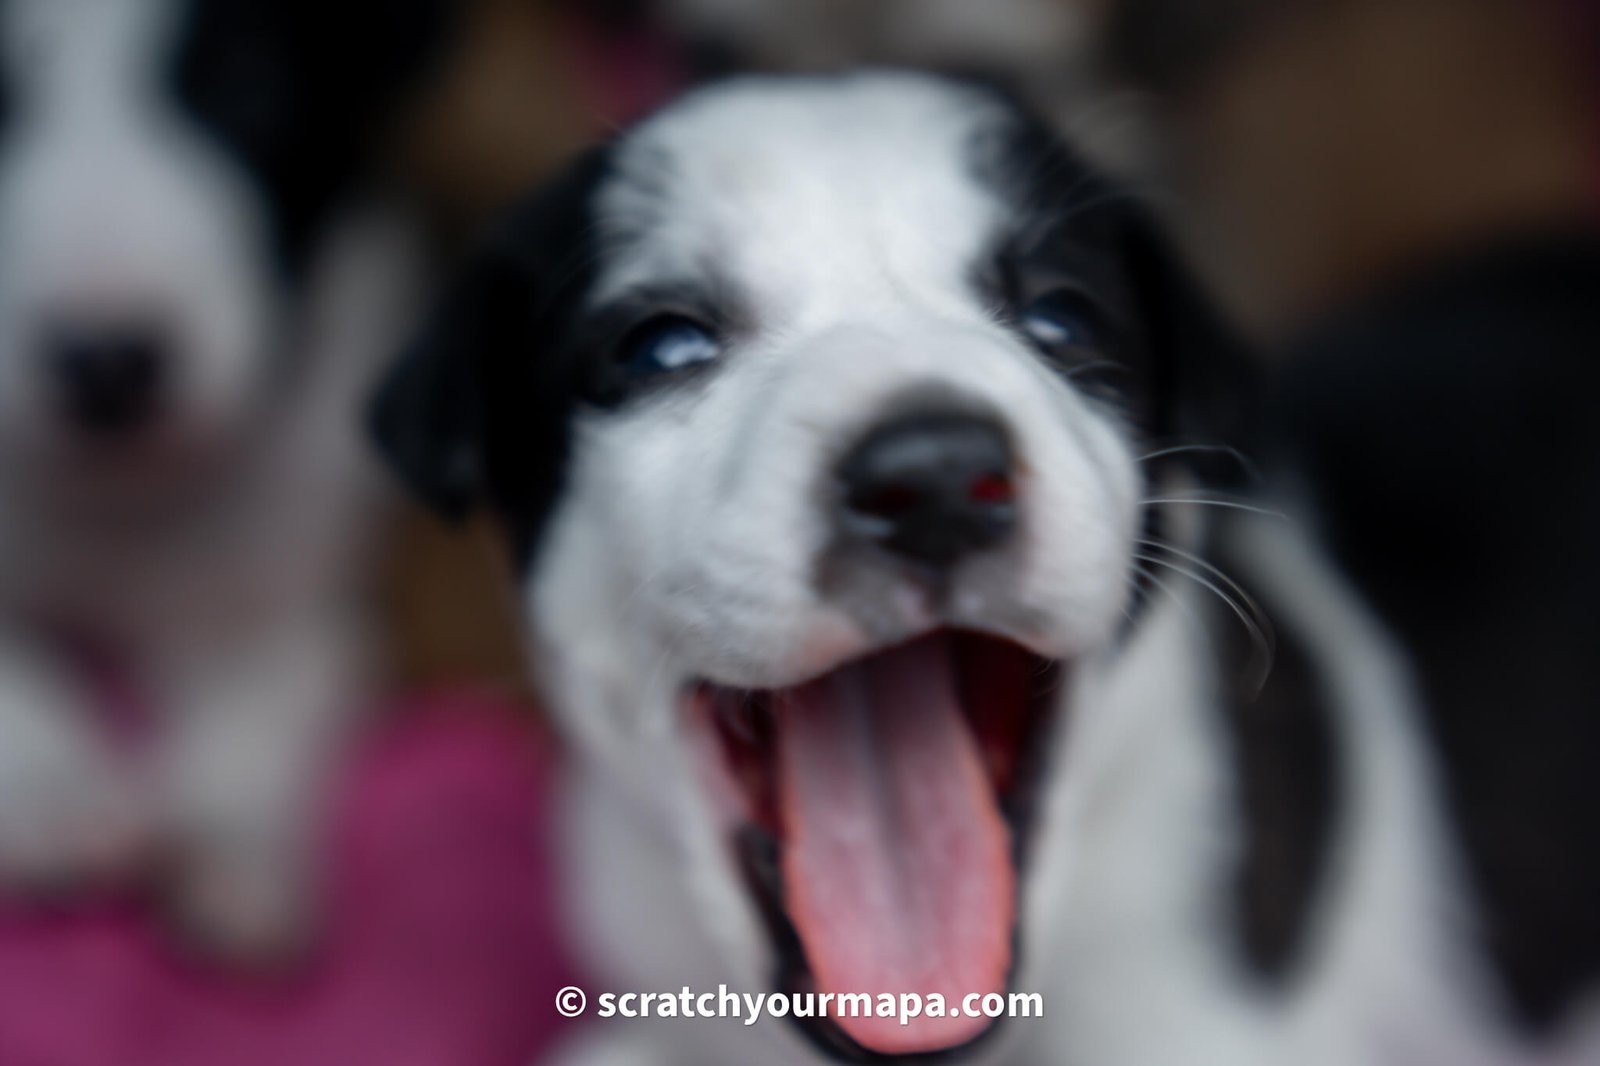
<box><xmin>778</xmin><ymin>637</ymin><xmax>1016</xmax><ymax>1055</ymax></box>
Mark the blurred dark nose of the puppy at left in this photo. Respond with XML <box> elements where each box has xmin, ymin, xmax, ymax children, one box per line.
<box><xmin>45</xmin><ymin>327</ymin><xmax>166</xmax><ymax>435</ymax></box>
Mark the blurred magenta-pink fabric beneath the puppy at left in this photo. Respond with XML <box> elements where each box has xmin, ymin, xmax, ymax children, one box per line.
<box><xmin>0</xmin><ymin>695</ymin><xmax>582</xmax><ymax>1066</ymax></box>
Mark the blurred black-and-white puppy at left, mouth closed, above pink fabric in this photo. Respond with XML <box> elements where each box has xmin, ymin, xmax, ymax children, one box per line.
<box><xmin>0</xmin><ymin>0</ymin><xmax>445</xmax><ymax>949</ymax></box>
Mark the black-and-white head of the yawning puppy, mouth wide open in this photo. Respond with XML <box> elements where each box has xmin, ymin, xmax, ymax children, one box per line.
<box><xmin>378</xmin><ymin>74</ymin><xmax>1235</xmax><ymax>1055</ymax></box>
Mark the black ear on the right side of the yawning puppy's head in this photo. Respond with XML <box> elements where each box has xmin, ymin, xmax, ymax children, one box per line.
<box><xmin>1123</xmin><ymin>206</ymin><xmax>1262</xmax><ymax>483</ymax></box>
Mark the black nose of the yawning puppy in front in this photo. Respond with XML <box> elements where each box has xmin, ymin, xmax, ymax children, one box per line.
<box><xmin>838</xmin><ymin>404</ymin><xmax>1016</xmax><ymax>568</ymax></box>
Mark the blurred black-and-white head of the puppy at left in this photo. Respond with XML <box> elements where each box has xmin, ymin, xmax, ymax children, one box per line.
<box><xmin>0</xmin><ymin>0</ymin><xmax>444</xmax><ymax>479</ymax></box>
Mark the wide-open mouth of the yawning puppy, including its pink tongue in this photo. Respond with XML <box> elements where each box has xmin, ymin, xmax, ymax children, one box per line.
<box><xmin>691</xmin><ymin>631</ymin><xmax>1062</xmax><ymax>1060</ymax></box>
